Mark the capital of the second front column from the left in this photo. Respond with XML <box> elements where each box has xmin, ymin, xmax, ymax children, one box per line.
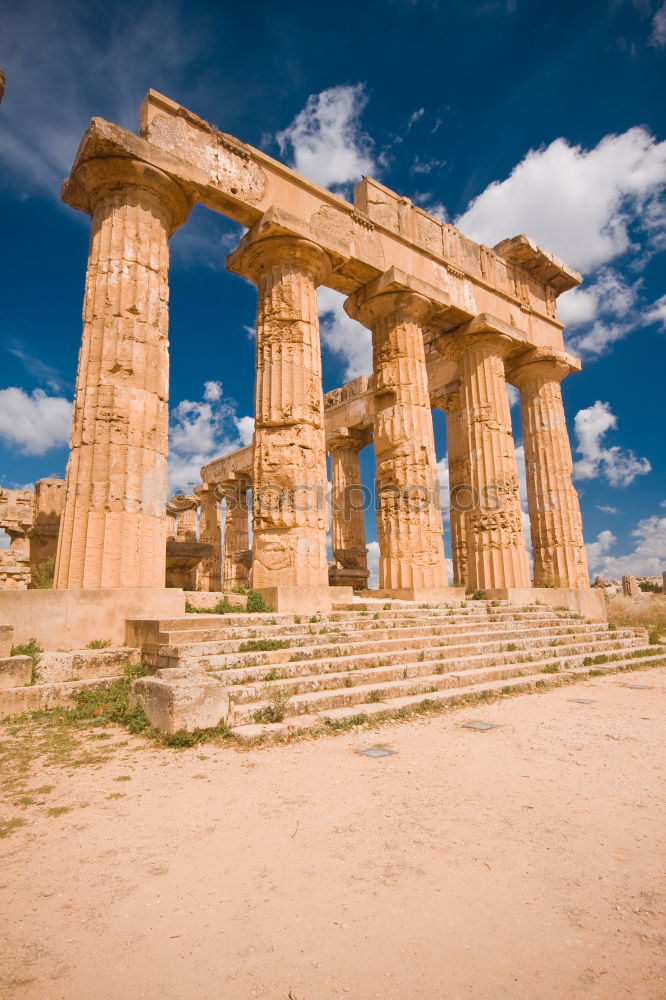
<box><xmin>227</xmin><ymin>231</ymin><xmax>332</xmax><ymax>285</ymax></box>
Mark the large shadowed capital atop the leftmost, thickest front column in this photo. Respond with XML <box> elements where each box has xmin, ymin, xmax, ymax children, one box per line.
<box><xmin>61</xmin><ymin>156</ymin><xmax>194</xmax><ymax>235</ymax></box>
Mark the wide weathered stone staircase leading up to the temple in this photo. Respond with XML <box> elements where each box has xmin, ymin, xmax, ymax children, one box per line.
<box><xmin>130</xmin><ymin>601</ymin><xmax>666</xmax><ymax>738</ymax></box>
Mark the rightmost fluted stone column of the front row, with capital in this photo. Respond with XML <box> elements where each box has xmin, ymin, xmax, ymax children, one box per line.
<box><xmin>509</xmin><ymin>348</ymin><xmax>590</xmax><ymax>590</ymax></box>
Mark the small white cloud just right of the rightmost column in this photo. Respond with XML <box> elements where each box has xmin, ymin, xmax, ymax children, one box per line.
<box><xmin>574</xmin><ymin>400</ymin><xmax>652</xmax><ymax>486</ymax></box>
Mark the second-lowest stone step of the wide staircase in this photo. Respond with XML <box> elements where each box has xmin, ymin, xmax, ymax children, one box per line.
<box><xmin>222</xmin><ymin>647</ymin><xmax>663</xmax><ymax>725</ymax></box>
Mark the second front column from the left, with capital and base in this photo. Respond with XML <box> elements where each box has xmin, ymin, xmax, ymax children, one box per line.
<box><xmin>228</xmin><ymin>231</ymin><xmax>330</xmax><ymax>610</ymax></box>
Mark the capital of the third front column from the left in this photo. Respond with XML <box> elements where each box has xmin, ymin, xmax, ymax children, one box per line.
<box><xmin>345</xmin><ymin>267</ymin><xmax>450</xmax><ymax>327</ymax></box>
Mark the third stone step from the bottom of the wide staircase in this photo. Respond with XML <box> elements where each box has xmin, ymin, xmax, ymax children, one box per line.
<box><xmin>167</xmin><ymin>630</ymin><xmax>641</xmax><ymax>673</ymax></box>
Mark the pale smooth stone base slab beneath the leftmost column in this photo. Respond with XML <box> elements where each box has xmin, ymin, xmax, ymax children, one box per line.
<box><xmin>0</xmin><ymin>587</ymin><xmax>185</xmax><ymax>650</ymax></box>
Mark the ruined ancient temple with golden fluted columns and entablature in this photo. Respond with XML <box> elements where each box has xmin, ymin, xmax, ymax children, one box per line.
<box><xmin>0</xmin><ymin>91</ymin><xmax>599</xmax><ymax>648</ymax></box>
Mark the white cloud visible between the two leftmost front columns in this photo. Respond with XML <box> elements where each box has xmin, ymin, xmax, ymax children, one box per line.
<box><xmin>169</xmin><ymin>381</ymin><xmax>254</xmax><ymax>492</ymax></box>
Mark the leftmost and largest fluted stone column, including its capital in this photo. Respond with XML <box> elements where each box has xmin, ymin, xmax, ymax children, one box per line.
<box><xmin>55</xmin><ymin>157</ymin><xmax>190</xmax><ymax>588</ymax></box>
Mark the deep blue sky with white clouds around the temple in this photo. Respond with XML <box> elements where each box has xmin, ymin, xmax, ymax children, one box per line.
<box><xmin>0</xmin><ymin>0</ymin><xmax>666</xmax><ymax>576</ymax></box>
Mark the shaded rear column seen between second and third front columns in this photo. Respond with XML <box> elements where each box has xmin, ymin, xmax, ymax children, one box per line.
<box><xmin>326</xmin><ymin>430</ymin><xmax>372</xmax><ymax>588</ymax></box>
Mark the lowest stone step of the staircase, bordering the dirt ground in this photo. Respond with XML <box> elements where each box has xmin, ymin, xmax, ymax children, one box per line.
<box><xmin>232</xmin><ymin>651</ymin><xmax>666</xmax><ymax>740</ymax></box>
